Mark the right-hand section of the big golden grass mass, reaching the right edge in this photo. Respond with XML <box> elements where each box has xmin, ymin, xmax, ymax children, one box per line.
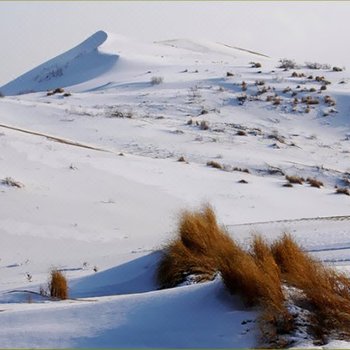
<box><xmin>271</xmin><ymin>234</ymin><xmax>350</xmax><ymax>342</ymax></box>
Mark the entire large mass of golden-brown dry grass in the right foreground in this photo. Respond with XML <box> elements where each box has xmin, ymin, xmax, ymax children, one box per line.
<box><xmin>157</xmin><ymin>205</ymin><xmax>350</xmax><ymax>348</ymax></box>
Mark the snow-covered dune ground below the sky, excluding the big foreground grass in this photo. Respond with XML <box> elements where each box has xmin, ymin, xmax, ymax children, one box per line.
<box><xmin>0</xmin><ymin>31</ymin><xmax>350</xmax><ymax>348</ymax></box>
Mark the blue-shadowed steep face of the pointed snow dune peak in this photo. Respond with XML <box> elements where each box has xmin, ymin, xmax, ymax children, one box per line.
<box><xmin>0</xmin><ymin>31</ymin><xmax>119</xmax><ymax>95</ymax></box>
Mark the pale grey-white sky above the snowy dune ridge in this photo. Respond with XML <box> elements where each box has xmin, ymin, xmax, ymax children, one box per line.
<box><xmin>0</xmin><ymin>1</ymin><xmax>350</xmax><ymax>85</ymax></box>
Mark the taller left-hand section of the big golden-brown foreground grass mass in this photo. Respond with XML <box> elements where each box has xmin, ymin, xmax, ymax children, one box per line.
<box><xmin>157</xmin><ymin>206</ymin><xmax>293</xmax><ymax>345</ymax></box>
